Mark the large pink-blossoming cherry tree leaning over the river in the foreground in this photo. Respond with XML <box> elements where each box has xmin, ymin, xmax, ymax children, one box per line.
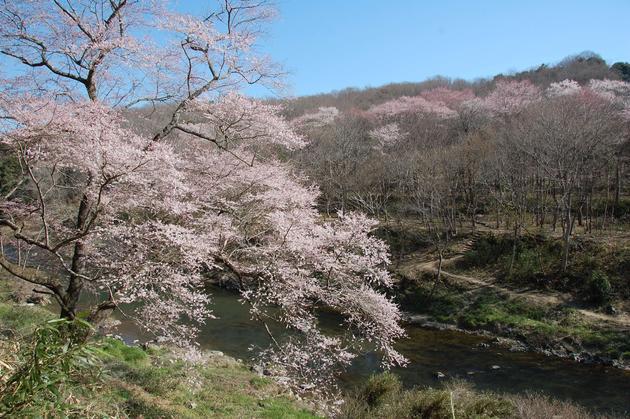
<box><xmin>0</xmin><ymin>0</ymin><xmax>405</xmax><ymax>388</ymax></box>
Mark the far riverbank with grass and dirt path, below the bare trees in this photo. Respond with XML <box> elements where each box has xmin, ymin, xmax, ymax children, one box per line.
<box><xmin>396</xmin><ymin>226</ymin><xmax>630</xmax><ymax>366</ymax></box>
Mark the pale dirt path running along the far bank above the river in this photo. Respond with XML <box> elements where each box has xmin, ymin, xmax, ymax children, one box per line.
<box><xmin>398</xmin><ymin>249</ymin><xmax>630</xmax><ymax>331</ymax></box>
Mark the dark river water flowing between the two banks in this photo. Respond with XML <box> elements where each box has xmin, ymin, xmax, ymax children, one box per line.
<box><xmin>115</xmin><ymin>288</ymin><xmax>630</xmax><ymax>417</ymax></box>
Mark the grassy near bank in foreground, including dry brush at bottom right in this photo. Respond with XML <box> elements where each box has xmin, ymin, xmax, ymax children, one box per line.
<box><xmin>0</xmin><ymin>276</ymin><xmax>628</xmax><ymax>419</ymax></box>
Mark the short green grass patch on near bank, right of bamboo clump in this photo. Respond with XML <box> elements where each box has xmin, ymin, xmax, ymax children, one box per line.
<box><xmin>100</xmin><ymin>351</ymin><xmax>317</xmax><ymax>418</ymax></box>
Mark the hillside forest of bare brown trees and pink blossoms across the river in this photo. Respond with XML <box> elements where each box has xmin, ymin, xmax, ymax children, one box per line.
<box><xmin>287</xmin><ymin>55</ymin><xmax>630</xmax><ymax>260</ymax></box>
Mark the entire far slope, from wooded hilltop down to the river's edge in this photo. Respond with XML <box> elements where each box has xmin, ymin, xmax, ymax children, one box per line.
<box><xmin>286</xmin><ymin>53</ymin><xmax>630</xmax><ymax>365</ymax></box>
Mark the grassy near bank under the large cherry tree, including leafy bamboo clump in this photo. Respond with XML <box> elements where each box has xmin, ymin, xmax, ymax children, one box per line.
<box><xmin>0</xmin><ymin>278</ymin><xmax>319</xmax><ymax>419</ymax></box>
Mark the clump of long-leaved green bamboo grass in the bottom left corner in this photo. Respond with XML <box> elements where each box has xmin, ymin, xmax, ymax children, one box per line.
<box><xmin>0</xmin><ymin>319</ymin><xmax>95</xmax><ymax>416</ymax></box>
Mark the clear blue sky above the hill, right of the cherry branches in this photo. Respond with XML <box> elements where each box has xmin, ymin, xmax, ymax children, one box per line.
<box><xmin>246</xmin><ymin>0</ymin><xmax>630</xmax><ymax>95</ymax></box>
